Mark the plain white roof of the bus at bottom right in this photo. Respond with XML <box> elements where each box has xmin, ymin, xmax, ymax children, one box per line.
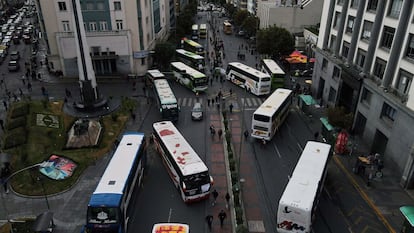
<box><xmin>279</xmin><ymin>141</ymin><xmax>331</xmax><ymax>212</ymax></box>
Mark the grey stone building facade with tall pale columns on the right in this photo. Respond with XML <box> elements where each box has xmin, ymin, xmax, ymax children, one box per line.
<box><xmin>312</xmin><ymin>0</ymin><xmax>414</xmax><ymax>188</ymax></box>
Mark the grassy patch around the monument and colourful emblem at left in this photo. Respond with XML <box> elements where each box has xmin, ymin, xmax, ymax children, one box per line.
<box><xmin>5</xmin><ymin>99</ymin><xmax>137</xmax><ymax>196</ymax></box>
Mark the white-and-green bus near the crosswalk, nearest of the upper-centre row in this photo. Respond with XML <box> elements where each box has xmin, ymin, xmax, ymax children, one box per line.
<box><xmin>171</xmin><ymin>62</ymin><xmax>208</xmax><ymax>93</ymax></box>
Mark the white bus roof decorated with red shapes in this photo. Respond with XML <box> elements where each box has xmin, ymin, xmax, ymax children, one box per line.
<box><xmin>153</xmin><ymin>121</ymin><xmax>208</xmax><ymax>176</ymax></box>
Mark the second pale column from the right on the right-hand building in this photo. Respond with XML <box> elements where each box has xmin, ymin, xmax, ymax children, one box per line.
<box><xmin>362</xmin><ymin>0</ymin><xmax>387</xmax><ymax>76</ymax></box>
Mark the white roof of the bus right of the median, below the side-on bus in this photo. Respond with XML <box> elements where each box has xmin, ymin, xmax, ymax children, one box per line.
<box><xmin>253</xmin><ymin>88</ymin><xmax>292</xmax><ymax>117</ymax></box>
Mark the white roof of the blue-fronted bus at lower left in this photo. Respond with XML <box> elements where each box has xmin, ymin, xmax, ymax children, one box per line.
<box><xmin>93</xmin><ymin>132</ymin><xmax>144</xmax><ymax>195</ymax></box>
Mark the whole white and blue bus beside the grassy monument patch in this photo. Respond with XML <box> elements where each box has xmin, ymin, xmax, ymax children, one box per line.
<box><xmin>84</xmin><ymin>132</ymin><xmax>146</xmax><ymax>233</ymax></box>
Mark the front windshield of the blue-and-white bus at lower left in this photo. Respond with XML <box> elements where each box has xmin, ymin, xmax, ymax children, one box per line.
<box><xmin>87</xmin><ymin>207</ymin><xmax>119</xmax><ymax>224</ymax></box>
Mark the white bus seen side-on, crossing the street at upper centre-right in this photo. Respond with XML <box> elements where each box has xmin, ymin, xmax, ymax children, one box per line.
<box><xmin>226</xmin><ymin>62</ymin><xmax>271</xmax><ymax>96</ymax></box>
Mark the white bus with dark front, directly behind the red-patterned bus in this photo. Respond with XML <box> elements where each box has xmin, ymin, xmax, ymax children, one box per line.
<box><xmin>154</xmin><ymin>79</ymin><xmax>180</xmax><ymax>121</ymax></box>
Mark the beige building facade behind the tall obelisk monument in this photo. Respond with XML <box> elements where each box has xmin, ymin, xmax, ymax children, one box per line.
<box><xmin>36</xmin><ymin>0</ymin><xmax>170</xmax><ymax>77</ymax></box>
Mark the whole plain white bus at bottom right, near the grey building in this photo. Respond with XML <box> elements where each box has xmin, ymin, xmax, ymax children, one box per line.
<box><xmin>277</xmin><ymin>141</ymin><xmax>331</xmax><ymax>233</ymax></box>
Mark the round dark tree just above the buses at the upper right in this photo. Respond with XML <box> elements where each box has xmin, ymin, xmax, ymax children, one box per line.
<box><xmin>256</xmin><ymin>26</ymin><xmax>295</xmax><ymax>57</ymax></box>
